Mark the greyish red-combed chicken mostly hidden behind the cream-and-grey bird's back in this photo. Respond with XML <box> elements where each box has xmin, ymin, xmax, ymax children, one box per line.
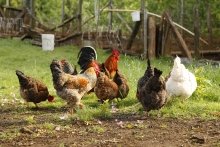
<box><xmin>61</xmin><ymin>59</ymin><xmax>78</xmax><ymax>75</ymax></box>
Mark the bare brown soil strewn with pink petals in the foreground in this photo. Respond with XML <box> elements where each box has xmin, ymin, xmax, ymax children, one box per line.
<box><xmin>0</xmin><ymin>105</ymin><xmax>220</xmax><ymax>147</ymax></box>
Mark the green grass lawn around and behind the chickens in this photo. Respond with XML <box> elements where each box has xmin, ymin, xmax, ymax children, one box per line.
<box><xmin>0</xmin><ymin>39</ymin><xmax>220</xmax><ymax>120</ymax></box>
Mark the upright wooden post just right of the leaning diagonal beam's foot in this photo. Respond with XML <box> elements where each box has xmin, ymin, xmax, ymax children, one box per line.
<box><xmin>194</xmin><ymin>6</ymin><xmax>200</xmax><ymax>60</ymax></box>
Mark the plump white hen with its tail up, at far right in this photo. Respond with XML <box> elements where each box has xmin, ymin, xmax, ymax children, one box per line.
<box><xmin>166</xmin><ymin>56</ymin><xmax>197</xmax><ymax>99</ymax></box>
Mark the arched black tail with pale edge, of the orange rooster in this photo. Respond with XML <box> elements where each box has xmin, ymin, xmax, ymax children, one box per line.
<box><xmin>77</xmin><ymin>46</ymin><xmax>97</xmax><ymax>69</ymax></box>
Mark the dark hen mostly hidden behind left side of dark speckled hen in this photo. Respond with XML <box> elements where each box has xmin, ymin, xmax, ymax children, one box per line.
<box><xmin>136</xmin><ymin>59</ymin><xmax>154</xmax><ymax>98</ymax></box>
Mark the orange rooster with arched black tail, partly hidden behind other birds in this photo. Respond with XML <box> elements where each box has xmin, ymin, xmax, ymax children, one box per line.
<box><xmin>77</xmin><ymin>46</ymin><xmax>120</xmax><ymax>78</ymax></box>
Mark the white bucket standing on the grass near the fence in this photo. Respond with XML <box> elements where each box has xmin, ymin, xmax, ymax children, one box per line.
<box><xmin>42</xmin><ymin>34</ymin><xmax>54</xmax><ymax>51</ymax></box>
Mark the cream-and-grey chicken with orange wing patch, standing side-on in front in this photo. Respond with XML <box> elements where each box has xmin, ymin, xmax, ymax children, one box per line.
<box><xmin>50</xmin><ymin>60</ymin><xmax>99</xmax><ymax>115</ymax></box>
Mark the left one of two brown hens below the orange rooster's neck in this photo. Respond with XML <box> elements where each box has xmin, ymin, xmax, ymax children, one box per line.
<box><xmin>94</xmin><ymin>72</ymin><xmax>118</xmax><ymax>103</ymax></box>
